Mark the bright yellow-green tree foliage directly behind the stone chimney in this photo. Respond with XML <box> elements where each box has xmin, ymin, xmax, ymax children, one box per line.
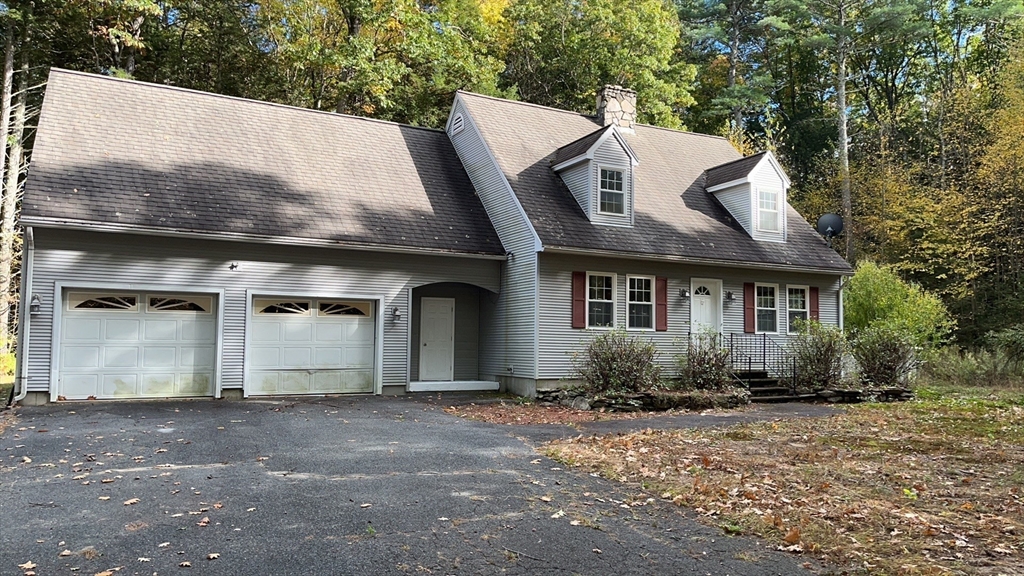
<box><xmin>503</xmin><ymin>0</ymin><xmax>696</xmax><ymax>128</ymax></box>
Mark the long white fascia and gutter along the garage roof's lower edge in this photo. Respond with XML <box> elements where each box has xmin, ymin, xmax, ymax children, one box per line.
<box><xmin>22</xmin><ymin>217</ymin><xmax>507</xmax><ymax>260</ymax></box>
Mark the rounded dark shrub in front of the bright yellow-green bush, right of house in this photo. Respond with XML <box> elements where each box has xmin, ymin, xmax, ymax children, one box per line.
<box><xmin>852</xmin><ymin>326</ymin><xmax>919</xmax><ymax>386</ymax></box>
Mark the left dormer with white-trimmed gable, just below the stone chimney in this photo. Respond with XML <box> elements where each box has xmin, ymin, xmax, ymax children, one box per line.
<box><xmin>551</xmin><ymin>124</ymin><xmax>639</xmax><ymax>227</ymax></box>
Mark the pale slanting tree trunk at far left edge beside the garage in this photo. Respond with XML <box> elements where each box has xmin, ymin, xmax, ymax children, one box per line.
<box><xmin>0</xmin><ymin>18</ymin><xmax>31</xmax><ymax>345</ymax></box>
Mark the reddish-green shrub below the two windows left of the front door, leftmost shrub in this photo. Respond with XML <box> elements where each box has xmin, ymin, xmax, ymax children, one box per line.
<box><xmin>572</xmin><ymin>329</ymin><xmax>662</xmax><ymax>393</ymax></box>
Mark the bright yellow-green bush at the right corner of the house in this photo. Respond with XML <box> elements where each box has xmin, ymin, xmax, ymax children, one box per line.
<box><xmin>843</xmin><ymin>261</ymin><xmax>954</xmax><ymax>347</ymax></box>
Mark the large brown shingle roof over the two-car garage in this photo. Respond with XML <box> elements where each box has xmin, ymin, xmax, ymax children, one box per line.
<box><xmin>22</xmin><ymin>70</ymin><xmax>504</xmax><ymax>254</ymax></box>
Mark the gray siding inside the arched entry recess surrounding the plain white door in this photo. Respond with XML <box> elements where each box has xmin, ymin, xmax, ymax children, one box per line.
<box><xmin>410</xmin><ymin>284</ymin><xmax>480</xmax><ymax>382</ymax></box>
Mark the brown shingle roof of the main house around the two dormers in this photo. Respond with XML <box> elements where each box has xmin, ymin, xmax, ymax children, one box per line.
<box><xmin>460</xmin><ymin>92</ymin><xmax>850</xmax><ymax>273</ymax></box>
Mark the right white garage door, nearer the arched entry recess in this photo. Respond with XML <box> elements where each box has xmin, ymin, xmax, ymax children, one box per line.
<box><xmin>248</xmin><ymin>298</ymin><xmax>374</xmax><ymax>395</ymax></box>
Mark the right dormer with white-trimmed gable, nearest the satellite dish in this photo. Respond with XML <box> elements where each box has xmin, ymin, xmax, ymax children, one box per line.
<box><xmin>705</xmin><ymin>151</ymin><xmax>790</xmax><ymax>242</ymax></box>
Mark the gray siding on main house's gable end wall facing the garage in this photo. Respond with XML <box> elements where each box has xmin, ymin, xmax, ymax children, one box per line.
<box><xmin>452</xmin><ymin>97</ymin><xmax>541</xmax><ymax>379</ymax></box>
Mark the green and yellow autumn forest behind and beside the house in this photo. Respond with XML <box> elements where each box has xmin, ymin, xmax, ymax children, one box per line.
<box><xmin>0</xmin><ymin>0</ymin><xmax>1024</xmax><ymax>345</ymax></box>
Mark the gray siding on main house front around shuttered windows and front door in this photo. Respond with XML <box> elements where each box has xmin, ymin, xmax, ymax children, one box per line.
<box><xmin>538</xmin><ymin>254</ymin><xmax>840</xmax><ymax>379</ymax></box>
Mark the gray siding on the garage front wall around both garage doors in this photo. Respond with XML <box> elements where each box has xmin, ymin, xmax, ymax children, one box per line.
<box><xmin>28</xmin><ymin>229</ymin><xmax>500</xmax><ymax>392</ymax></box>
